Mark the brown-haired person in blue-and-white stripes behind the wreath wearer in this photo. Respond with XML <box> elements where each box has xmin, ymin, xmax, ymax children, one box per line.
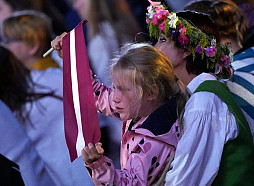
<box><xmin>184</xmin><ymin>0</ymin><xmax>254</xmax><ymax>142</ymax></box>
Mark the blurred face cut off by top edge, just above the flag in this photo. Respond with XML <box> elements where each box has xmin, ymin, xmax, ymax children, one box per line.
<box><xmin>72</xmin><ymin>0</ymin><xmax>90</xmax><ymax>19</ymax></box>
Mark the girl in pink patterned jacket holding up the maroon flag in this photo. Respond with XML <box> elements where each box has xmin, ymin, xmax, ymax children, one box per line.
<box><xmin>52</xmin><ymin>37</ymin><xmax>187</xmax><ymax>185</ymax></box>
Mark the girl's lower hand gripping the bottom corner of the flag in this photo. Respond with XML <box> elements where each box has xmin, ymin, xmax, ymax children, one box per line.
<box><xmin>81</xmin><ymin>142</ymin><xmax>104</xmax><ymax>165</ymax></box>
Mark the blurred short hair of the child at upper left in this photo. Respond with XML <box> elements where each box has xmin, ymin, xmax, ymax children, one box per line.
<box><xmin>2</xmin><ymin>10</ymin><xmax>52</xmax><ymax>56</ymax></box>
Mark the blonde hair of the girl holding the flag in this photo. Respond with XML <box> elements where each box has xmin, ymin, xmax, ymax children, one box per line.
<box><xmin>111</xmin><ymin>43</ymin><xmax>188</xmax><ymax>127</ymax></box>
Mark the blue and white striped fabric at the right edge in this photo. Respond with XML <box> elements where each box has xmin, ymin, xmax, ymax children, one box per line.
<box><xmin>228</xmin><ymin>47</ymin><xmax>254</xmax><ymax>141</ymax></box>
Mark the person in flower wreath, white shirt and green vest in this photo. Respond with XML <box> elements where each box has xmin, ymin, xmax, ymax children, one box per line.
<box><xmin>147</xmin><ymin>0</ymin><xmax>254</xmax><ymax>186</ymax></box>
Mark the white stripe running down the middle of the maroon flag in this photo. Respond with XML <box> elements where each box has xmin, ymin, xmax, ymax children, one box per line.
<box><xmin>70</xmin><ymin>30</ymin><xmax>85</xmax><ymax>157</ymax></box>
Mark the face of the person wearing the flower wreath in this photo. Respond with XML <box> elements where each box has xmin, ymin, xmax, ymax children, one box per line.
<box><xmin>155</xmin><ymin>34</ymin><xmax>182</xmax><ymax>68</ymax></box>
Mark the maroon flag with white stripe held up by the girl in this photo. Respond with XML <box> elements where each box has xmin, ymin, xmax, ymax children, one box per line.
<box><xmin>62</xmin><ymin>21</ymin><xmax>101</xmax><ymax>161</ymax></box>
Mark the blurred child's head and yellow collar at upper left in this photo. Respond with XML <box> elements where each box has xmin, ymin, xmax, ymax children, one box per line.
<box><xmin>2</xmin><ymin>10</ymin><xmax>60</xmax><ymax>71</ymax></box>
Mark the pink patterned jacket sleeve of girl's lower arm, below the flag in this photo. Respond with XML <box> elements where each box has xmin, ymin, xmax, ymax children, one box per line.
<box><xmin>87</xmin><ymin>136</ymin><xmax>175</xmax><ymax>186</ymax></box>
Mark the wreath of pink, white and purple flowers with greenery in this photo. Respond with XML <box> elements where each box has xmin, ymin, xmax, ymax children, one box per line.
<box><xmin>146</xmin><ymin>0</ymin><xmax>233</xmax><ymax>79</ymax></box>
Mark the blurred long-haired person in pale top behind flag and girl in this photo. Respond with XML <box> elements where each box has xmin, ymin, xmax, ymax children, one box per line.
<box><xmin>71</xmin><ymin>0</ymin><xmax>144</xmax><ymax>164</ymax></box>
